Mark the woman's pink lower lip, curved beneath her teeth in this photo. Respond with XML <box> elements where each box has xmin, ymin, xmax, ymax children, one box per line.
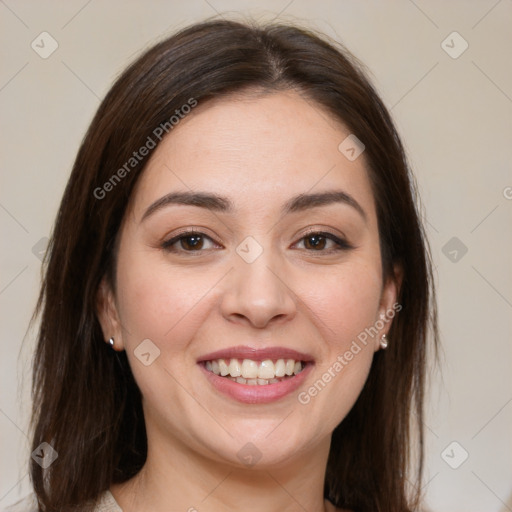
<box><xmin>199</xmin><ymin>363</ymin><xmax>313</xmax><ymax>404</ymax></box>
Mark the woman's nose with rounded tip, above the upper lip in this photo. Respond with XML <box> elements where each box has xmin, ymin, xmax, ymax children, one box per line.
<box><xmin>221</xmin><ymin>251</ymin><xmax>296</xmax><ymax>329</ymax></box>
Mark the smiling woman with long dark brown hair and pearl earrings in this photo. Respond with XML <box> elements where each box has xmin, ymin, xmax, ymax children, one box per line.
<box><xmin>15</xmin><ymin>17</ymin><xmax>437</xmax><ymax>512</ymax></box>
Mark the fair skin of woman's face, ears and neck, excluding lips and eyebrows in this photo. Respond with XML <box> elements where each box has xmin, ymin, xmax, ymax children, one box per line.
<box><xmin>98</xmin><ymin>91</ymin><xmax>399</xmax><ymax>512</ymax></box>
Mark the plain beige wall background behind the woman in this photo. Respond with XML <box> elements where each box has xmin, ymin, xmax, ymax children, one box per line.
<box><xmin>0</xmin><ymin>0</ymin><xmax>512</xmax><ymax>512</ymax></box>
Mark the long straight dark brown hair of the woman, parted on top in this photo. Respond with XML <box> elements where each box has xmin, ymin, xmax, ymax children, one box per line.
<box><xmin>31</xmin><ymin>21</ymin><xmax>437</xmax><ymax>512</ymax></box>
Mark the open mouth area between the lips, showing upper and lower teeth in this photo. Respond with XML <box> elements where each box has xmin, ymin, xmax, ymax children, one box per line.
<box><xmin>202</xmin><ymin>358</ymin><xmax>307</xmax><ymax>386</ymax></box>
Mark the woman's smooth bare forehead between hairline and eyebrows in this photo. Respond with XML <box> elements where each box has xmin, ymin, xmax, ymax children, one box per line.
<box><xmin>128</xmin><ymin>91</ymin><xmax>373</xmax><ymax>220</ymax></box>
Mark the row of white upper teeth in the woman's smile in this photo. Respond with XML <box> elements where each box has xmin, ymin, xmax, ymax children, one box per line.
<box><xmin>205</xmin><ymin>359</ymin><xmax>302</xmax><ymax>379</ymax></box>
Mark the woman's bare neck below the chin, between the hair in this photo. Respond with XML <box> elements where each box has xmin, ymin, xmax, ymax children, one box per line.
<box><xmin>111</xmin><ymin>424</ymin><xmax>333</xmax><ymax>512</ymax></box>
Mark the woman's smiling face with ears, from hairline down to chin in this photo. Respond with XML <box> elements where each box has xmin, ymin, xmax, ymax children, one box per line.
<box><xmin>100</xmin><ymin>92</ymin><xmax>396</xmax><ymax>467</ymax></box>
